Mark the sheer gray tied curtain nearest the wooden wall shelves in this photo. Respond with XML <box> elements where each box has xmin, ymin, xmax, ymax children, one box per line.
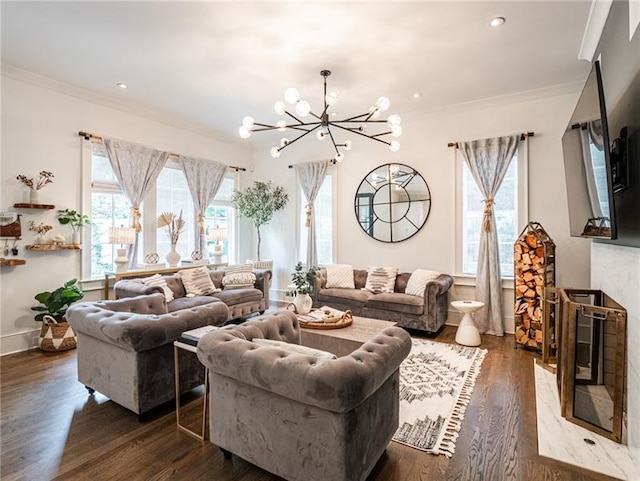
<box><xmin>103</xmin><ymin>138</ymin><xmax>169</xmax><ymax>268</ymax></box>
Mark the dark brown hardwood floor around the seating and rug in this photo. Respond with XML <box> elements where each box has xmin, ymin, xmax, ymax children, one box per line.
<box><xmin>0</xmin><ymin>327</ymin><xmax>613</xmax><ymax>481</ymax></box>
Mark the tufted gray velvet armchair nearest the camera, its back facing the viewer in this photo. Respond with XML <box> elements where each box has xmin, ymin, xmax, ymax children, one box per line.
<box><xmin>198</xmin><ymin>311</ymin><xmax>411</xmax><ymax>481</ymax></box>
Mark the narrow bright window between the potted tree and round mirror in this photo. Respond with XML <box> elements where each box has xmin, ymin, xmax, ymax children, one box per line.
<box><xmin>299</xmin><ymin>172</ymin><xmax>335</xmax><ymax>266</ymax></box>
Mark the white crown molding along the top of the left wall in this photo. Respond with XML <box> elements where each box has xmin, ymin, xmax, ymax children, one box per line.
<box><xmin>0</xmin><ymin>63</ymin><xmax>243</xmax><ymax>145</ymax></box>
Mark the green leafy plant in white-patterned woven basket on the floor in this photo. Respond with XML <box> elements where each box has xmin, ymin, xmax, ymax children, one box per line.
<box><xmin>31</xmin><ymin>279</ymin><xmax>84</xmax><ymax>352</ymax></box>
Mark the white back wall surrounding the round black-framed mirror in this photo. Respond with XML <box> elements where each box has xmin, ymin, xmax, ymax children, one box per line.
<box><xmin>254</xmin><ymin>88</ymin><xmax>590</xmax><ymax>332</ymax></box>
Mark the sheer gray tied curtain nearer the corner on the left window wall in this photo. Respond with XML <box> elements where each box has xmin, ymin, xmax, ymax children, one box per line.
<box><xmin>180</xmin><ymin>155</ymin><xmax>228</xmax><ymax>256</ymax></box>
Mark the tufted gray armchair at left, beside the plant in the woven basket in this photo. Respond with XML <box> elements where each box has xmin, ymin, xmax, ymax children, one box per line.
<box><xmin>66</xmin><ymin>293</ymin><xmax>229</xmax><ymax>418</ymax></box>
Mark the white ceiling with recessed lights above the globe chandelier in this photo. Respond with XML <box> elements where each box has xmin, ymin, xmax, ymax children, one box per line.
<box><xmin>0</xmin><ymin>0</ymin><xmax>591</xmax><ymax>139</ymax></box>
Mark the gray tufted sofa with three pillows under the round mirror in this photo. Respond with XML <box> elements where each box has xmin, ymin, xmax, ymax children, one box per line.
<box><xmin>312</xmin><ymin>269</ymin><xmax>453</xmax><ymax>333</ymax></box>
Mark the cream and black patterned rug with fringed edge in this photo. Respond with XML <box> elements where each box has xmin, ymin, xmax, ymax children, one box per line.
<box><xmin>393</xmin><ymin>339</ymin><xmax>487</xmax><ymax>457</ymax></box>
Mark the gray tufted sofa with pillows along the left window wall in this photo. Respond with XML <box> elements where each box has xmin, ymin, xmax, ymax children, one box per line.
<box><xmin>114</xmin><ymin>269</ymin><xmax>271</xmax><ymax>320</ymax></box>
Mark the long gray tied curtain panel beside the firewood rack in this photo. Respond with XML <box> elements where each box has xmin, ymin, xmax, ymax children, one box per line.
<box><xmin>458</xmin><ymin>135</ymin><xmax>520</xmax><ymax>336</ymax></box>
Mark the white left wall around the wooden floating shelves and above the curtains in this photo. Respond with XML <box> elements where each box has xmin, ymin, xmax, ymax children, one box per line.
<box><xmin>0</xmin><ymin>70</ymin><xmax>252</xmax><ymax>354</ymax></box>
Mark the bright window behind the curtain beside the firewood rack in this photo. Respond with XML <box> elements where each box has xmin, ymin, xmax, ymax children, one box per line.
<box><xmin>458</xmin><ymin>152</ymin><xmax>527</xmax><ymax>277</ymax></box>
